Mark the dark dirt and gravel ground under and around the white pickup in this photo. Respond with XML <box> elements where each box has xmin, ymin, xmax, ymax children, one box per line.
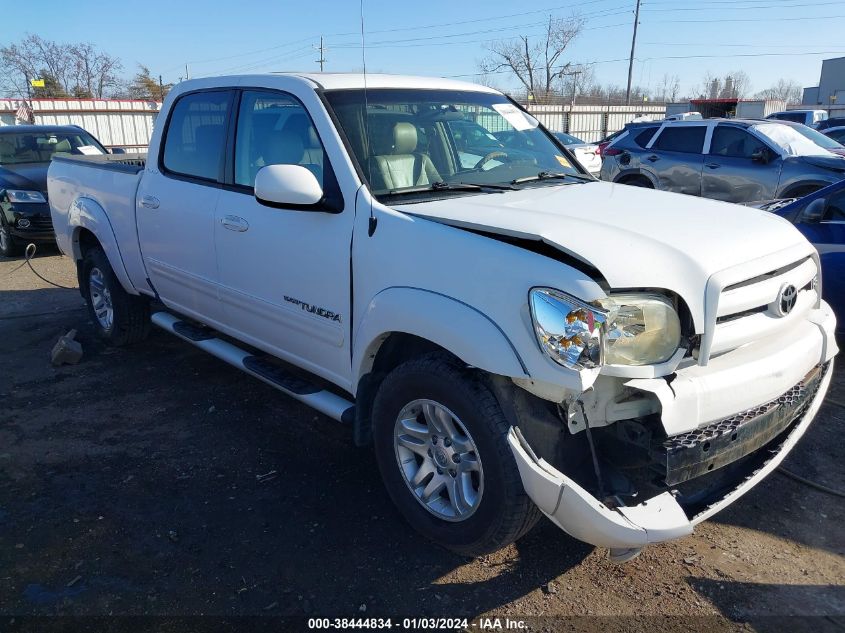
<box><xmin>0</xmin><ymin>249</ymin><xmax>845</xmax><ymax>633</ymax></box>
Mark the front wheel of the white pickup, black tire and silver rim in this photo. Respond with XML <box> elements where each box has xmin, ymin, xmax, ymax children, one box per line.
<box><xmin>373</xmin><ymin>353</ymin><xmax>540</xmax><ymax>556</ymax></box>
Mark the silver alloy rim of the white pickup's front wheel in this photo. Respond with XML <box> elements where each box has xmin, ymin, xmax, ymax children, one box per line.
<box><xmin>393</xmin><ymin>400</ymin><xmax>484</xmax><ymax>522</ymax></box>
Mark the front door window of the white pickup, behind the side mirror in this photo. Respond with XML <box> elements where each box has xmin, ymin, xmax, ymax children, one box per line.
<box><xmin>235</xmin><ymin>91</ymin><xmax>325</xmax><ymax>187</ymax></box>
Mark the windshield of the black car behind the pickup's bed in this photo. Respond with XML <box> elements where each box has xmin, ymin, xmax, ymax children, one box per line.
<box><xmin>0</xmin><ymin>130</ymin><xmax>106</xmax><ymax>165</ymax></box>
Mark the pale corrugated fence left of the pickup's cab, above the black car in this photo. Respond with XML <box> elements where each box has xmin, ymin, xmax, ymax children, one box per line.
<box><xmin>0</xmin><ymin>99</ymin><xmax>161</xmax><ymax>151</ymax></box>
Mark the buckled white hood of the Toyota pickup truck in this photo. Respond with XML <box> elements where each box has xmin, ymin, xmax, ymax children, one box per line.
<box><xmin>397</xmin><ymin>182</ymin><xmax>812</xmax><ymax>318</ymax></box>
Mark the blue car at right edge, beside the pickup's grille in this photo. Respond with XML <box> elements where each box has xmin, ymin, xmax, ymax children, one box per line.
<box><xmin>762</xmin><ymin>180</ymin><xmax>845</xmax><ymax>332</ymax></box>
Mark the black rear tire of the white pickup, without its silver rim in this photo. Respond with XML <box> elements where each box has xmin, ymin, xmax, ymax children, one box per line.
<box><xmin>81</xmin><ymin>248</ymin><xmax>150</xmax><ymax>347</ymax></box>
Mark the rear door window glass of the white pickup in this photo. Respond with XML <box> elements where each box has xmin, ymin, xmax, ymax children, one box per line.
<box><xmin>162</xmin><ymin>91</ymin><xmax>229</xmax><ymax>181</ymax></box>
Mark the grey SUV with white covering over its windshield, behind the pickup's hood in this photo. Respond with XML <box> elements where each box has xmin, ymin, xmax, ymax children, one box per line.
<box><xmin>601</xmin><ymin>119</ymin><xmax>845</xmax><ymax>202</ymax></box>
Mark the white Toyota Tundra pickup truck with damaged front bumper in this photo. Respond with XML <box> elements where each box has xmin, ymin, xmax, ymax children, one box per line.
<box><xmin>48</xmin><ymin>74</ymin><xmax>838</xmax><ymax>561</ymax></box>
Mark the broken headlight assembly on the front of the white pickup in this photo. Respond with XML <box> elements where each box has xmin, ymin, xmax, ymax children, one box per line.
<box><xmin>530</xmin><ymin>288</ymin><xmax>681</xmax><ymax>369</ymax></box>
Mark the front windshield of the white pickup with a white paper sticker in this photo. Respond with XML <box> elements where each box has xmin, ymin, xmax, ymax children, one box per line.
<box><xmin>325</xmin><ymin>89</ymin><xmax>584</xmax><ymax>198</ymax></box>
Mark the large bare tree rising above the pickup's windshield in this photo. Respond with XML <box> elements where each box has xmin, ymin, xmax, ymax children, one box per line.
<box><xmin>480</xmin><ymin>16</ymin><xmax>584</xmax><ymax>99</ymax></box>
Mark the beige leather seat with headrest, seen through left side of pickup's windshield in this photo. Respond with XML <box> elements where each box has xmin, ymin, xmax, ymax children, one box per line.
<box><xmin>370</xmin><ymin>121</ymin><xmax>442</xmax><ymax>191</ymax></box>
